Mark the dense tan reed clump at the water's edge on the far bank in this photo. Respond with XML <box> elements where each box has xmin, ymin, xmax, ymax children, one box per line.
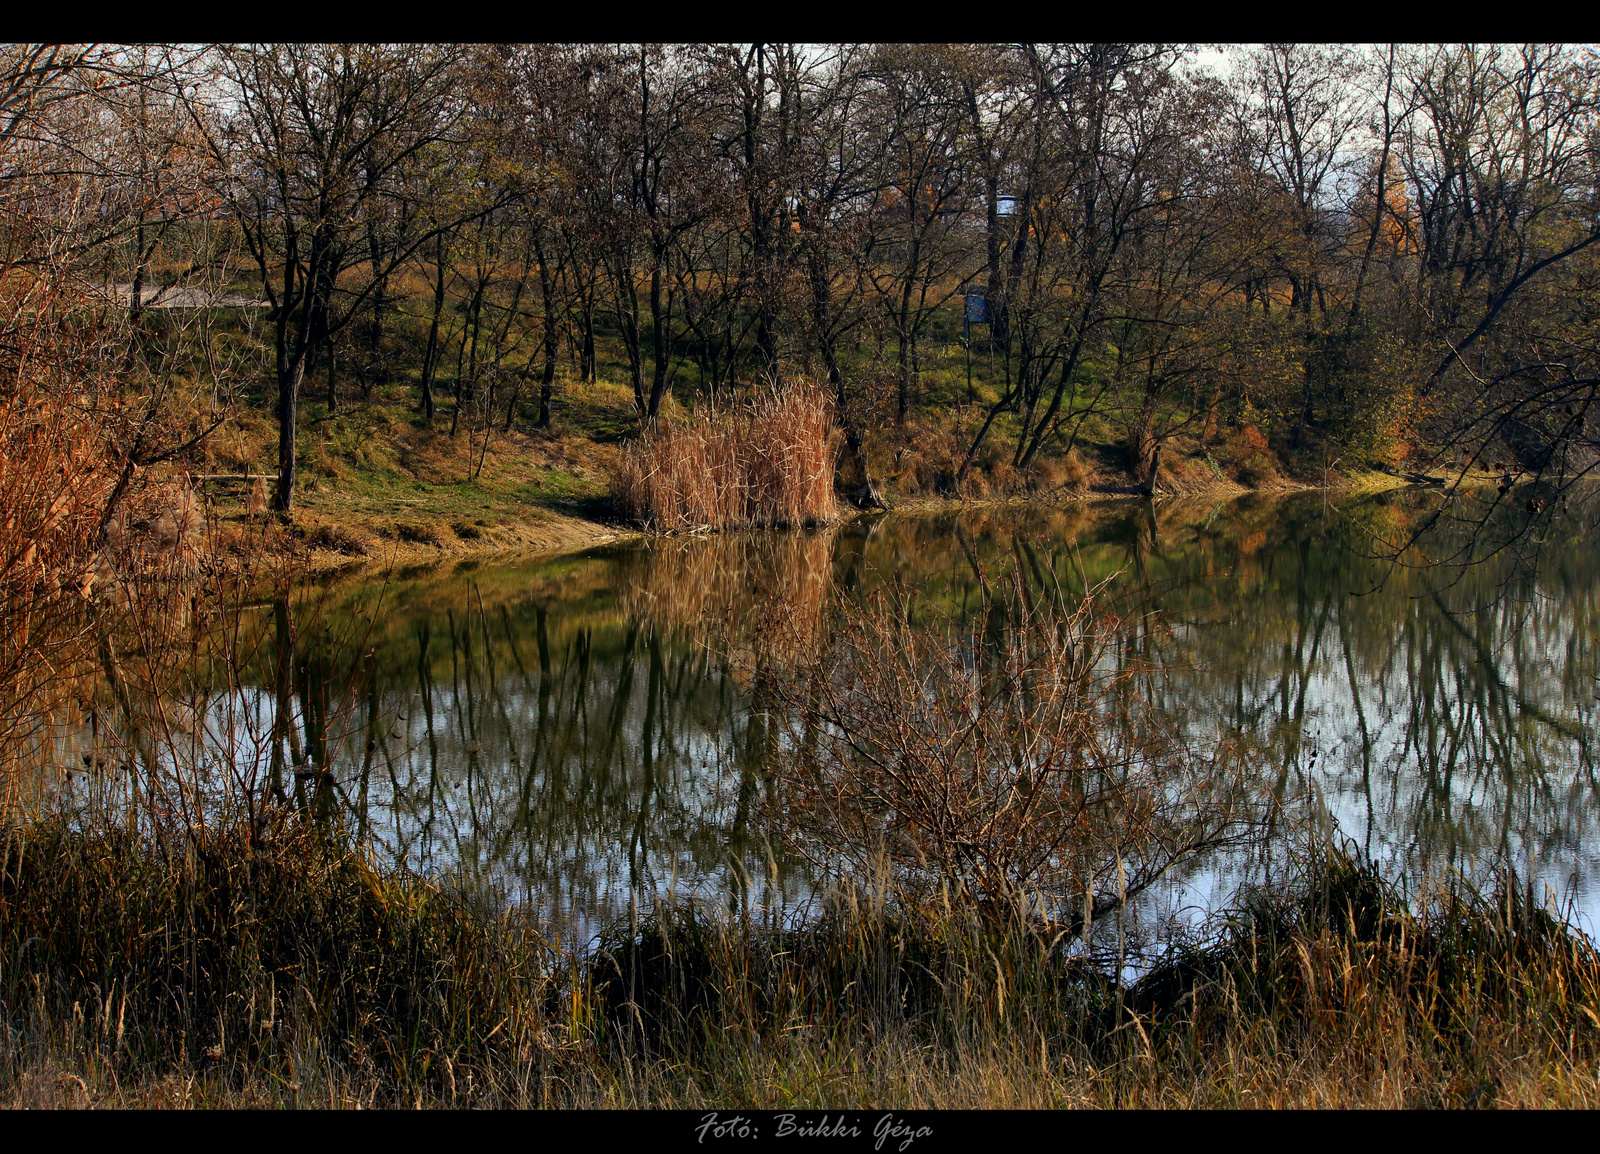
<box><xmin>611</xmin><ymin>384</ymin><xmax>840</xmax><ymax>530</ymax></box>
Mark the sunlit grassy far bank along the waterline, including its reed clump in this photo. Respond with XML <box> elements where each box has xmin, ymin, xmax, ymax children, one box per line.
<box><xmin>190</xmin><ymin>364</ymin><xmax>1376</xmax><ymax>568</ymax></box>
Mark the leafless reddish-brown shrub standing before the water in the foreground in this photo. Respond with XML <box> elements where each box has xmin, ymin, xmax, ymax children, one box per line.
<box><xmin>758</xmin><ymin>563</ymin><xmax>1250</xmax><ymax>930</ymax></box>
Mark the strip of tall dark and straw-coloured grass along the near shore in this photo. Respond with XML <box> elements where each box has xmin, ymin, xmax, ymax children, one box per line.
<box><xmin>0</xmin><ymin>815</ymin><xmax>1600</xmax><ymax>1108</ymax></box>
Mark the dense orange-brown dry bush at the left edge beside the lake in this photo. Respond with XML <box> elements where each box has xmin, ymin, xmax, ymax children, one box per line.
<box><xmin>0</xmin><ymin>281</ymin><xmax>216</xmax><ymax>808</ymax></box>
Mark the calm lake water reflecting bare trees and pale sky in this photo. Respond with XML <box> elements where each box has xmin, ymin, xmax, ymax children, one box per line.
<box><xmin>37</xmin><ymin>493</ymin><xmax>1600</xmax><ymax>928</ymax></box>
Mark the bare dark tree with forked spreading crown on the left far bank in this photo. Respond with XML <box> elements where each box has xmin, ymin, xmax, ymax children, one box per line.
<box><xmin>195</xmin><ymin>45</ymin><xmax>505</xmax><ymax>512</ymax></box>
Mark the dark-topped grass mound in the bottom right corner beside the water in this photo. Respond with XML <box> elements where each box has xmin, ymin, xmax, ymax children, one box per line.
<box><xmin>1128</xmin><ymin>851</ymin><xmax>1600</xmax><ymax>1106</ymax></box>
